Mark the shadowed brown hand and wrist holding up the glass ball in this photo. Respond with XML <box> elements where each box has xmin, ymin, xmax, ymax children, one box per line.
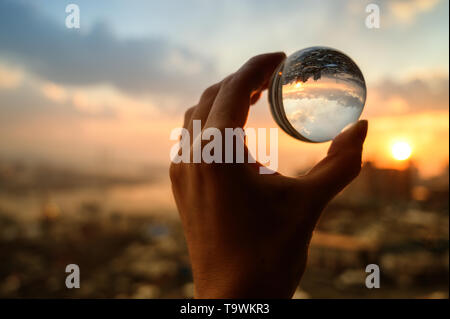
<box><xmin>170</xmin><ymin>53</ymin><xmax>367</xmax><ymax>298</ymax></box>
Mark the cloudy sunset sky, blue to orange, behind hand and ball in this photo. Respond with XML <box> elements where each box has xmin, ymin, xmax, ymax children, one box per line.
<box><xmin>0</xmin><ymin>0</ymin><xmax>449</xmax><ymax>176</ymax></box>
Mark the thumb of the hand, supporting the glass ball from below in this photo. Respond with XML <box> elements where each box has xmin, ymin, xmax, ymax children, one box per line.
<box><xmin>306</xmin><ymin>120</ymin><xmax>368</xmax><ymax>201</ymax></box>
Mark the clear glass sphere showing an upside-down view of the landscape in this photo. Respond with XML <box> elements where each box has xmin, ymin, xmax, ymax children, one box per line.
<box><xmin>269</xmin><ymin>47</ymin><xmax>366</xmax><ymax>143</ymax></box>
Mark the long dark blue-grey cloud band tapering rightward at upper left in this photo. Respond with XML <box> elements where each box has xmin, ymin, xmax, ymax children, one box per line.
<box><xmin>0</xmin><ymin>0</ymin><xmax>214</xmax><ymax>99</ymax></box>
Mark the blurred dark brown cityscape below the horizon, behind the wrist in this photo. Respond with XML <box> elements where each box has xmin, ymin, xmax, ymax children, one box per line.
<box><xmin>0</xmin><ymin>160</ymin><xmax>449</xmax><ymax>298</ymax></box>
